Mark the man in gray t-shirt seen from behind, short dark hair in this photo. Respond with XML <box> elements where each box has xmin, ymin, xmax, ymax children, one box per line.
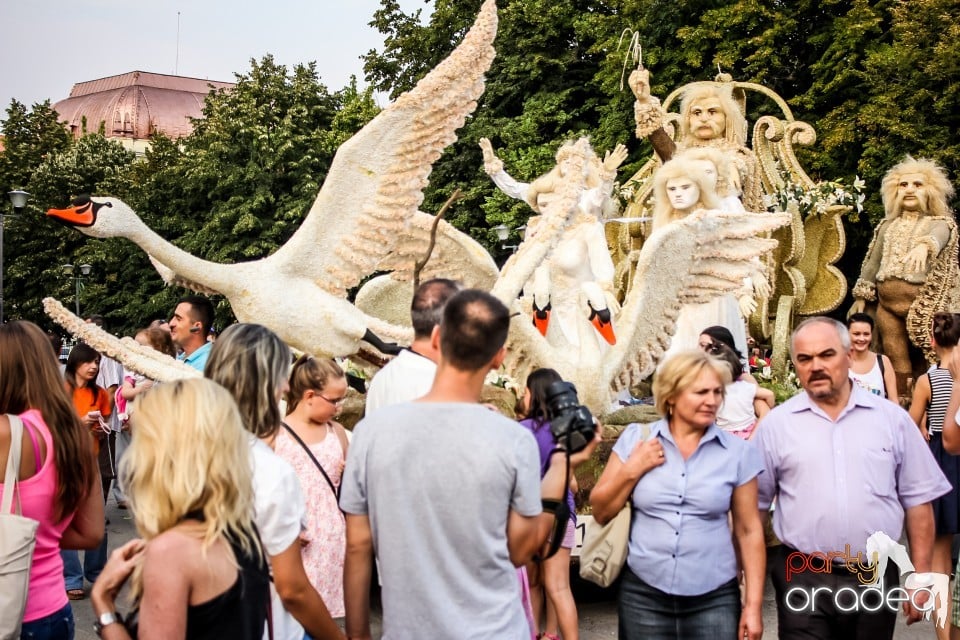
<box><xmin>340</xmin><ymin>289</ymin><xmax>599</xmax><ymax>639</ymax></box>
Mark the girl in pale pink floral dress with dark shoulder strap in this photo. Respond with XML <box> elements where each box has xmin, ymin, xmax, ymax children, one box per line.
<box><xmin>275</xmin><ymin>355</ymin><xmax>347</xmax><ymax>618</ymax></box>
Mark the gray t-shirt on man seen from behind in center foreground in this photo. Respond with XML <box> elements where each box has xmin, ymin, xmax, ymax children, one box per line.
<box><xmin>340</xmin><ymin>403</ymin><xmax>541</xmax><ymax>640</ymax></box>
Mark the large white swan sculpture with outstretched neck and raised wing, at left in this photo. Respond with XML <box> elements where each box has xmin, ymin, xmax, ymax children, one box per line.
<box><xmin>47</xmin><ymin>0</ymin><xmax>497</xmax><ymax>356</ymax></box>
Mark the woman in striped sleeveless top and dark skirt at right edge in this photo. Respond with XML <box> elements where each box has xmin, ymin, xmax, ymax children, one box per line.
<box><xmin>910</xmin><ymin>312</ymin><xmax>960</xmax><ymax>640</ymax></box>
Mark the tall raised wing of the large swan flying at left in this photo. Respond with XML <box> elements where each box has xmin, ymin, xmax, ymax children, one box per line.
<box><xmin>275</xmin><ymin>0</ymin><xmax>497</xmax><ymax>296</ymax></box>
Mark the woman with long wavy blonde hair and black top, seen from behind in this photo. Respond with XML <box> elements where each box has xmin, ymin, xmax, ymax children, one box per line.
<box><xmin>91</xmin><ymin>379</ymin><xmax>270</xmax><ymax>640</ymax></box>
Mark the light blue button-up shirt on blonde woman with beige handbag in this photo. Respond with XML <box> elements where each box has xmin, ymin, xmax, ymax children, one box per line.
<box><xmin>613</xmin><ymin>420</ymin><xmax>763</xmax><ymax>596</ymax></box>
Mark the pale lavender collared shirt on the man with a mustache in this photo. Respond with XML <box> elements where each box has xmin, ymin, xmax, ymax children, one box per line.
<box><xmin>754</xmin><ymin>385</ymin><xmax>950</xmax><ymax>554</ymax></box>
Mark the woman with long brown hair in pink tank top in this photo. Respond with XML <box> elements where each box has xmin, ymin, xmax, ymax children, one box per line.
<box><xmin>0</xmin><ymin>321</ymin><xmax>104</xmax><ymax>639</ymax></box>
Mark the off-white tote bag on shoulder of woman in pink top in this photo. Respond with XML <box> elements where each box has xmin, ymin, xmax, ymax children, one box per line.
<box><xmin>0</xmin><ymin>414</ymin><xmax>40</xmax><ymax>640</ymax></box>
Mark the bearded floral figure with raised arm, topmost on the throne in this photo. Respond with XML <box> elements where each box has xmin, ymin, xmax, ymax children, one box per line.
<box><xmin>629</xmin><ymin>69</ymin><xmax>766</xmax><ymax>211</ymax></box>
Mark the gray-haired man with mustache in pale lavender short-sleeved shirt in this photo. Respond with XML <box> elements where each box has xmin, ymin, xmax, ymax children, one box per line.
<box><xmin>755</xmin><ymin>317</ymin><xmax>950</xmax><ymax>640</ymax></box>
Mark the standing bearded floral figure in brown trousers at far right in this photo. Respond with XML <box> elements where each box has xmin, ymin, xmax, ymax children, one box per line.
<box><xmin>850</xmin><ymin>156</ymin><xmax>960</xmax><ymax>389</ymax></box>
